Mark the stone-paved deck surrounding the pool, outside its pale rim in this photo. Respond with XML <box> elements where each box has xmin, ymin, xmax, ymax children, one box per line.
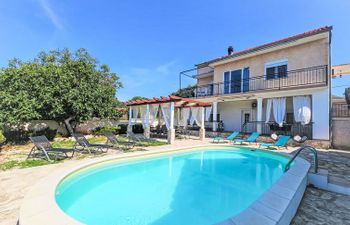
<box><xmin>0</xmin><ymin>139</ymin><xmax>350</xmax><ymax>225</ymax></box>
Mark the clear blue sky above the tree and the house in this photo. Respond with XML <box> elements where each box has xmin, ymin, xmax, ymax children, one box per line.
<box><xmin>0</xmin><ymin>0</ymin><xmax>350</xmax><ymax>101</ymax></box>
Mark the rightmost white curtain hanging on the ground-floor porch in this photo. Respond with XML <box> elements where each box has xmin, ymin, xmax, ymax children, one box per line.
<box><xmin>293</xmin><ymin>96</ymin><xmax>311</xmax><ymax>125</ymax></box>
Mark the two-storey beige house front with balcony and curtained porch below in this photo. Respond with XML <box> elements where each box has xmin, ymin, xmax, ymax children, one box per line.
<box><xmin>185</xmin><ymin>26</ymin><xmax>332</xmax><ymax>140</ymax></box>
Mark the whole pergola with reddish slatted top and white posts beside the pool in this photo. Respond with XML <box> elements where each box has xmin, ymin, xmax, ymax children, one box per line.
<box><xmin>124</xmin><ymin>96</ymin><xmax>211</xmax><ymax>144</ymax></box>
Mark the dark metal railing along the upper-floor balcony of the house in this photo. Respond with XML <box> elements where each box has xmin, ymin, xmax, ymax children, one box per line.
<box><xmin>193</xmin><ymin>65</ymin><xmax>328</xmax><ymax>97</ymax></box>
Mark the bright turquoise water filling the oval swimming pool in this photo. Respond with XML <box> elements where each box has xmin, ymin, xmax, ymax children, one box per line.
<box><xmin>56</xmin><ymin>148</ymin><xmax>288</xmax><ymax>225</ymax></box>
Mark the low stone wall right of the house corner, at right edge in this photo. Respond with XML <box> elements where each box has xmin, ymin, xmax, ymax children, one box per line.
<box><xmin>332</xmin><ymin>117</ymin><xmax>350</xmax><ymax>150</ymax></box>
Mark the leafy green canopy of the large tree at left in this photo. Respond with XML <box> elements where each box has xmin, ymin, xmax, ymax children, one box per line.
<box><xmin>0</xmin><ymin>49</ymin><xmax>122</xmax><ymax>124</ymax></box>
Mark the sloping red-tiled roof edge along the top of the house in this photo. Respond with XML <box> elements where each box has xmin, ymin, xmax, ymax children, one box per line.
<box><xmin>196</xmin><ymin>26</ymin><xmax>332</xmax><ymax>66</ymax></box>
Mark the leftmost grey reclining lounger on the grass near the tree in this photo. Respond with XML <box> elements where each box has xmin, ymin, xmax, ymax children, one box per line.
<box><xmin>27</xmin><ymin>136</ymin><xmax>75</xmax><ymax>162</ymax></box>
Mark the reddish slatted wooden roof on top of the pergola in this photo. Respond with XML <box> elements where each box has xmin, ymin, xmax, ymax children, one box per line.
<box><xmin>124</xmin><ymin>95</ymin><xmax>211</xmax><ymax>107</ymax></box>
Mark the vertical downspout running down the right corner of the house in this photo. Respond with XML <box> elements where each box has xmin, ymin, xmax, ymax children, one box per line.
<box><xmin>327</xmin><ymin>26</ymin><xmax>333</xmax><ymax>148</ymax></box>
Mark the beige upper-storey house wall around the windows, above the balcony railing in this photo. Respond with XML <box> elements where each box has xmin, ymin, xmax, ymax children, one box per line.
<box><xmin>214</xmin><ymin>38</ymin><xmax>328</xmax><ymax>83</ymax></box>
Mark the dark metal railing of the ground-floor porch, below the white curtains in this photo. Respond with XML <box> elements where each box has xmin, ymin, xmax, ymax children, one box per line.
<box><xmin>241</xmin><ymin>121</ymin><xmax>312</xmax><ymax>139</ymax></box>
